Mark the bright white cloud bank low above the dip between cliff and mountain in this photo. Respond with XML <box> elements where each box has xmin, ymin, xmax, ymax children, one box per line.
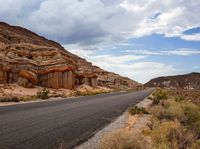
<box><xmin>70</xmin><ymin>49</ymin><xmax>177</xmax><ymax>83</ymax></box>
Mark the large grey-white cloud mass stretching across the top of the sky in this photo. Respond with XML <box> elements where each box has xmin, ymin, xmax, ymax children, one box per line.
<box><xmin>0</xmin><ymin>0</ymin><xmax>200</xmax><ymax>46</ymax></box>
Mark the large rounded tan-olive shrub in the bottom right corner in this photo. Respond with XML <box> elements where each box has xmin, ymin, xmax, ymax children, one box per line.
<box><xmin>151</xmin><ymin>121</ymin><xmax>195</xmax><ymax>149</ymax></box>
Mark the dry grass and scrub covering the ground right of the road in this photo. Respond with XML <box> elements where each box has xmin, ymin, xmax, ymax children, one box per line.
<box><xmin>100</xmin><ymin>89</ymin><xmax>200</xmax><ymax>149</ymax></box>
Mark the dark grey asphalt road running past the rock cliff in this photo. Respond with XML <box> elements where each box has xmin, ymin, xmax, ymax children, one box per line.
<box><xmin>0</xmin><ymin>89</ymin><xmax>152</xmax><ymax>149</ymax></box>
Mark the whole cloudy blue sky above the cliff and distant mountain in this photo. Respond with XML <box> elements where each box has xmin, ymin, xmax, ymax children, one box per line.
<box><xmin>0</xmin><ymin>0</ymin><xmax>200</xmax><ymax>83</ymax></box>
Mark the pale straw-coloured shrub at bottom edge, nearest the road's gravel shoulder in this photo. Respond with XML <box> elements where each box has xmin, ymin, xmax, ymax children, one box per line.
<box><xmin>99</xmin><ymin>129</ymin><xmax>148</xmax><ymax>149</ymax></box>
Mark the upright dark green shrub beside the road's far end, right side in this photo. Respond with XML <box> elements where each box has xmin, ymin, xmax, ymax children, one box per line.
<box><xmin>152</xmin><ymin>88</ymin><xmax>167</xmax><ymax>105</ymax></box>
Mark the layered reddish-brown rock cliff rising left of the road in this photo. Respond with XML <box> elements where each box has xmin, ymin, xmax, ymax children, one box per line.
<box><xmin>0</xmin><ymin>23</ymin><xmax>138</xmax><ymax>89</ymax></box>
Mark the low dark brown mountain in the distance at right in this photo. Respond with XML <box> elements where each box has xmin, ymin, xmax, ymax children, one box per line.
<box><xmin>145</xmin><ymin>72</ymin><xmax>200</xmax><ymax>90</ymax></box>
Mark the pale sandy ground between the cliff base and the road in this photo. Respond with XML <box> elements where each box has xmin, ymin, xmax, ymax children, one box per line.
<box><xmin>0</xmin><ymin>84</ymin><xmax>112</xmax><ymax>106</ymax></box>
